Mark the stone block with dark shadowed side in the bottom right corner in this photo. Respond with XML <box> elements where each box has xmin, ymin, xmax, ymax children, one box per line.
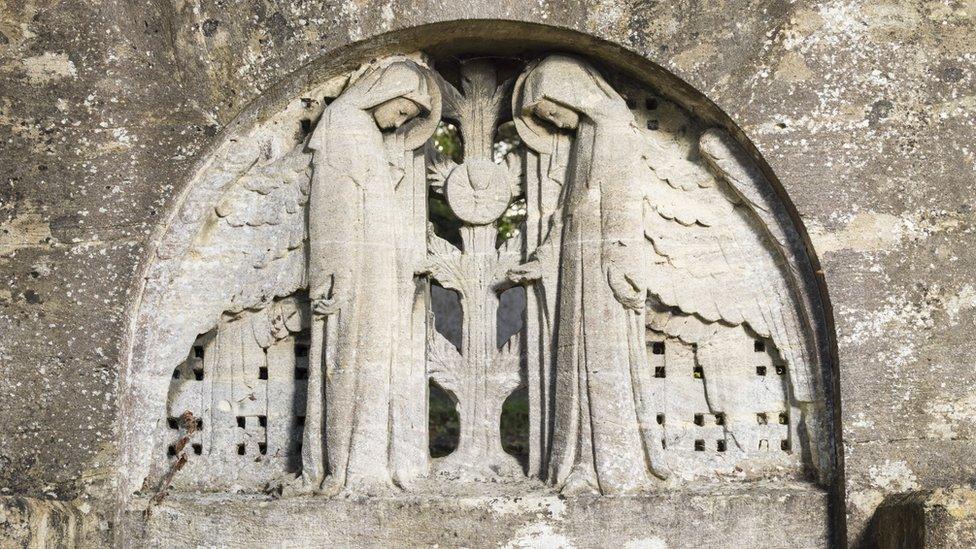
<box><xmin>872</xmin><ymin>486</ymin><xmax>976</xmax><ymax>549</ymax></box>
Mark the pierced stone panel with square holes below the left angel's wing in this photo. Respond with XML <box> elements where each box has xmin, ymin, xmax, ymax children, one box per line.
<box><xmin>159</xmin><ymin>299</ymin><xmax>309</xmax><ymax>490</ymax></box>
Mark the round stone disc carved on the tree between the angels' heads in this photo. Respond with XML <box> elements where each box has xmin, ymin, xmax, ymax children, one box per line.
<box><xmin>444</xmin><ymin>159</ymin><xmax>512</xmax><ymax>225</ymax></box>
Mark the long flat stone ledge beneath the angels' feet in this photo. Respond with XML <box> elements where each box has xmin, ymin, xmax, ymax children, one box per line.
<box><xmin>126</xmin><ymin>483</ymin><xmax>829</xmax><ymax>548</ymax></box>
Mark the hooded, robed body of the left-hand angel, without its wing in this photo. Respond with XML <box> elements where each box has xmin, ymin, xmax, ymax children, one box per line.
<box><xmin>302</xmin><ymin>58</ymin><xmax>440</xmax><ymax>492</ymax></box>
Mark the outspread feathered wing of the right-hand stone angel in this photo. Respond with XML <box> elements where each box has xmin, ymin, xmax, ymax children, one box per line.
<box><xmin>644</xmin><ymin>128</ymin><xmax>816</xmax><ymax>402</ymax></box>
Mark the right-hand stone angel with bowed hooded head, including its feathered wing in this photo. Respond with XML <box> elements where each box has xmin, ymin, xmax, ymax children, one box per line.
<box><xmin>510</xmin><ymin>55</ymin><xmax>815</xmax><ymax>494</ymax></box>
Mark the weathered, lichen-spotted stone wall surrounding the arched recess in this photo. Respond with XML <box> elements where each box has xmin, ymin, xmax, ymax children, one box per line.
<box><xmin>0</xmin><ymin>0</ymin><xmax>976</xmax><ymax>540</ymax></box>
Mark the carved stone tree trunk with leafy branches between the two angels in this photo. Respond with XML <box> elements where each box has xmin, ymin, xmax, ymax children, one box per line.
<box><xmin>428</xmin><ymin>61</ymin><xmax>523</xmax><ymax>477</ymax></box>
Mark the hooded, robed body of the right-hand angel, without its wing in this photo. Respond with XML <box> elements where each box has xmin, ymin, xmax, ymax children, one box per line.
<box><xmin>523</xmin><ymin>56</ymin><xmax>653</xmax><ymax>494</ymax></box>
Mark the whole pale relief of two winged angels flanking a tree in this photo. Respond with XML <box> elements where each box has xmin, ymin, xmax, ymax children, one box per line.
<box><xmin>147</xmin><ymin>55</ymin><xmax>830</xmax><ymax>495</ymax></box>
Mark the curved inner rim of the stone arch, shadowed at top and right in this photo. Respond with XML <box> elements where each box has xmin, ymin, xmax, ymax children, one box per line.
<box><xmin>116</xmin><ymin>19</ymin><xmax>845</xmax><ymax>540</ymax></box>
